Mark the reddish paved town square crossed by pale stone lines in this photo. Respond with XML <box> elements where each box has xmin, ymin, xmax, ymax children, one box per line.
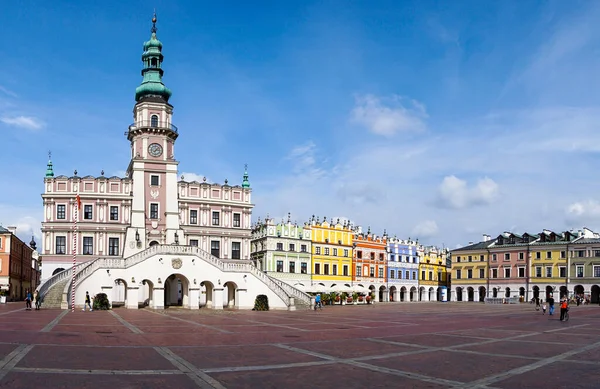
<box><xmin>0</xmin><ymin>303</ymin><xmax>600</xmax><ymax>389</ymax></box>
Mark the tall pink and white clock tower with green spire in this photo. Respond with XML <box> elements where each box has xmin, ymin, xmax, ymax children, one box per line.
<box><xmin>124</xmin><ymin>14</ymin><xmax>183</xmax><ymax>257</ymax></box>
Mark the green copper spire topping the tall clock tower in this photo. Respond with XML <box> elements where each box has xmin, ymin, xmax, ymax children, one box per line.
<box><xmin>135</xmin><ymin>13</ymin><xmax>171</xmax><ymax>103</ymax></box>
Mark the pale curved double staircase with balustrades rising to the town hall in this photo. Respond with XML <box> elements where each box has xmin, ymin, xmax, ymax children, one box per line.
<box><xmin>38</xmin><ymin>244</ymin><xmax>310</xmax><ymax>309</ymax></box>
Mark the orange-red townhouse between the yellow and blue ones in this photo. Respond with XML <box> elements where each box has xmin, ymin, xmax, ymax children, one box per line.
<box><xmin>352</xmin><ymin>227</ymin><xmax>389</xmax><ymax>302</ymax></box>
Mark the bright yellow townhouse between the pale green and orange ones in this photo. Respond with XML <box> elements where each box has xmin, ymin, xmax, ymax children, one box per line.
<box><xmin>311</xmin><ymin>216</ymin><xmax>354</xmax><ymax>287</ymax></box>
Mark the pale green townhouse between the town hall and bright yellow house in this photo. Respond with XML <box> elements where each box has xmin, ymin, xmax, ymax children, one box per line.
<box><xmin>250</xmin><ymin>213</ymin><xmax>312</xmax><ymax>289</ymax></box>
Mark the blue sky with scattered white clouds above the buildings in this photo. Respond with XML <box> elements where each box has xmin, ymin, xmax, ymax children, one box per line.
<box><xmin>0</xmin><ymin>1</ymin><xmax>600</xmax><ymax>247</ymax></box>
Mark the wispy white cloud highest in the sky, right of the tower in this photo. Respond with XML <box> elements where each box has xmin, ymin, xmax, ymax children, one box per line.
<box><xmin>351</xmin><ymin>94</ymin><xmax>427</xmax><ymax>137</ymax></box>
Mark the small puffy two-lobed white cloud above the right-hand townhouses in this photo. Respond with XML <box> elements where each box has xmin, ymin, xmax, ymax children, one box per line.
<box><xmin>437</xmin><ymin>175</ymin><xmax>499</xmax><ymax>209</ymax></box>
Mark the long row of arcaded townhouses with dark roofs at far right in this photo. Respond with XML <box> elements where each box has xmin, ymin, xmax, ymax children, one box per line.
<box><xmin>451</xmin><ymin>228</ymin><xmax>600</xmax><ymax>302</ymax></box>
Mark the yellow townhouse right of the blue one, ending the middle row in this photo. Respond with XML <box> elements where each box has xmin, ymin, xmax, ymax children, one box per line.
<box><xmin>417</xmin><ymin>246</ymin><xmax>449</xmax><ymax>301</ymax></box>
